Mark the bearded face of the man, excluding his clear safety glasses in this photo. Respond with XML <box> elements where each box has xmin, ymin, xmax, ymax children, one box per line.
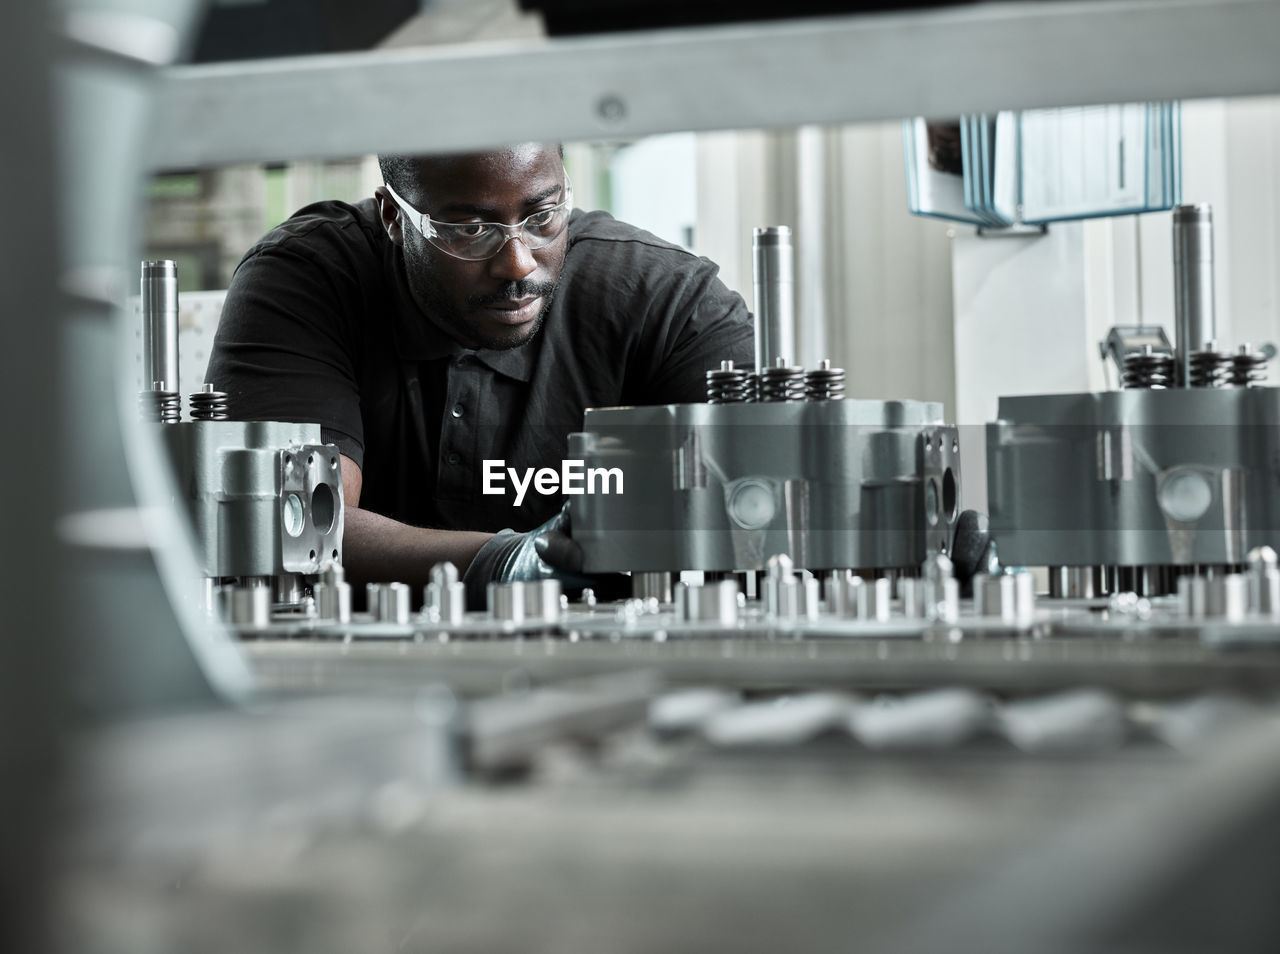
<box><xmin>380</xmin><ymin>145</ymin><xmax>568</xmax><ymax>350</ymax></box>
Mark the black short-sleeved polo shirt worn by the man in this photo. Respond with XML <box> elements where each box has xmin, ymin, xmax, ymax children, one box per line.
<box><xmin>205</xmin><ymin>198</ymin><xmax>753</xmax><ymax>530</ymax></box>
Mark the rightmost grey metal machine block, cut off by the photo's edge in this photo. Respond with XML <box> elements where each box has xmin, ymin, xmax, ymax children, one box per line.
<box><xmin>987</xmin><ymin>388</ymin><xmax>1280</xmax><ymax>576</ymax></box>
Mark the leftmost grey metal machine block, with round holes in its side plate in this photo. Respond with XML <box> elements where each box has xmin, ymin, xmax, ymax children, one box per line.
<box><xmin>160</xmin><ymin>420</ymin><xmax>342</xmax><ymax>579</ymax></box>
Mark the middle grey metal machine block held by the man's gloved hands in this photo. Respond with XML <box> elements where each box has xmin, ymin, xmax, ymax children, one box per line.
<box><xmin>568</xmin><ymin>400</ymin><xmax>960</xmax><ymax>572</ymax></box>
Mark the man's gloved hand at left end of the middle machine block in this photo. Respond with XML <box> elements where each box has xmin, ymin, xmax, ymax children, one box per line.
<box><xmin>462</xmin><ymin>502</ymin><xmax>630</xmax><ymax>610</ymax></box>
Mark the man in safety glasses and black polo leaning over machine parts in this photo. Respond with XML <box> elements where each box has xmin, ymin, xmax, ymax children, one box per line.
<box><xmin>206</xmin><ymin>145</ymin><xmax>753</xmax><ymax>604</ymax></box>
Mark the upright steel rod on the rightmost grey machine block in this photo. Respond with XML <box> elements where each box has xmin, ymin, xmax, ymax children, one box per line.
<box><xmin>1174</xmin><ymin>202</ymin><xmax>1217</xmax><ymax>388</ymax></box>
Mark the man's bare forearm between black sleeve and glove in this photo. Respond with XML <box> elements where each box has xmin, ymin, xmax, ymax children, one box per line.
<box><xmin>342</xmin><ymin>507</ymin><xmax>493</xmax><ymax>586</ymax></box>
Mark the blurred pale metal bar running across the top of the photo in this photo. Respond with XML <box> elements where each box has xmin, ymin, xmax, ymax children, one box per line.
<box><xmin>147</xmin><ymin>0</ymin><xmax>1280</xmax><ymax>169</ymax></box>
